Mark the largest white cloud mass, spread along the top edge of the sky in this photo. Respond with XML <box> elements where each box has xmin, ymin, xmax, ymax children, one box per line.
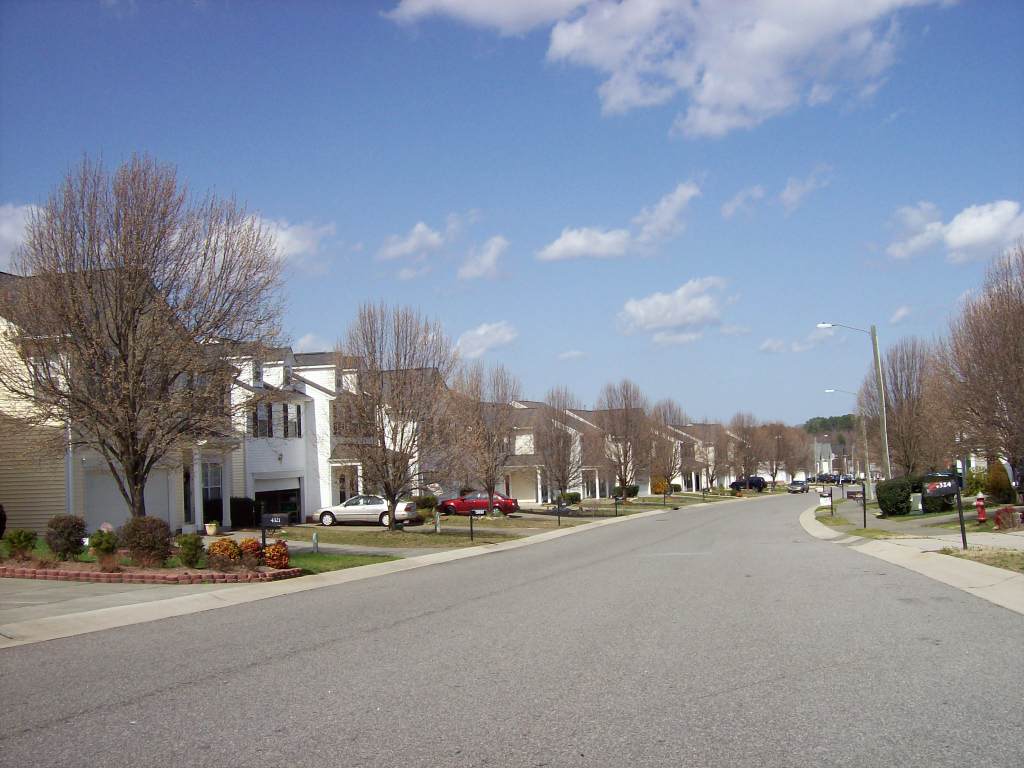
<box><xmin>397</xmin><ymin>0</ymin><xmax>947</xmax><ymax>136</ymax></box>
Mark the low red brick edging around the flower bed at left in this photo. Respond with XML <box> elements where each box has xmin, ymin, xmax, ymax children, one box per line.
<box><xmin>0</xmin><ymin>561</ymin><xmax>302</xmax><ymax>584</ymax></box>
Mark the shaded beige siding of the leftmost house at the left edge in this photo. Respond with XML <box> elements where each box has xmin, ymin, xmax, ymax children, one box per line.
<box><xmin>0</xmin><ymin>420</ymin><xmax>65</xmax><ymax>530</ymax></box>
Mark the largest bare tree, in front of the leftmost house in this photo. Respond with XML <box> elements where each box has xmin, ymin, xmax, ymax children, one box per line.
<box><xmin>0</xmin><ymin>157</ymin><xmax>281</xmax><ymax>516</ymax></box>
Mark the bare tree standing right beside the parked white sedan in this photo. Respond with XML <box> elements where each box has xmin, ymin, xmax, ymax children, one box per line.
<box><xmin>336</xmin><ymin>304</ymin><xmax>456</xmax><ymax>530</ymax></box>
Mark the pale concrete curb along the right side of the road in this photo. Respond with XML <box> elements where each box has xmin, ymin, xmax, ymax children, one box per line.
<box><xmin>800</xmin><ymin>507</ymin><xmax>1024</xmax><ymax>614</ymax></box>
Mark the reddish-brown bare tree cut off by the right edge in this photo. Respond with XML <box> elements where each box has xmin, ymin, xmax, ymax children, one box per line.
<box><xmin>943</xmin><ymin>240</ymin><xmax>1024</xmax><ymax>478</ymax></box>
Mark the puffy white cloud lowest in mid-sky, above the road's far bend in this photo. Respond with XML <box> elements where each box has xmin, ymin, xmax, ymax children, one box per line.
<box><xmin>618</xmin><ymin>276</ymin><xmax>726</xmax><ymax>333</ymax></box>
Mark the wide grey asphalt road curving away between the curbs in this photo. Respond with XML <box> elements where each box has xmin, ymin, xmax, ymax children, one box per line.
<box><xmin>0</xmin><ymin>496</ymin><xmax>1024</xmax><ymax>768</ymax></box>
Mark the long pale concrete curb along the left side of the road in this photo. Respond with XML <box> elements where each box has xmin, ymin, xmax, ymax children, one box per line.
<box><xmin>0</xmin><ymin>502</ymin><xmax>700</xmax><ymax>649</ymax></box>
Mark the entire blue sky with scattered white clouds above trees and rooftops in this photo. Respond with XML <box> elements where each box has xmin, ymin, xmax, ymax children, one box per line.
<box><xmin>0</xmin><ymin>0</ymin><xmax>1024</xmax><ymax>423</ymax></box>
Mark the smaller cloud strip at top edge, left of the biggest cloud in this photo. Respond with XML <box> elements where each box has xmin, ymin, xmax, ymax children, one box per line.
<box><xmin>386</xmin><ymin>0</ymin><xmax>585</xmax><ymax>35</ymax></box>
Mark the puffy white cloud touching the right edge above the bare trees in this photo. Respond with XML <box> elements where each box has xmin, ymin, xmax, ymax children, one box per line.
<box><xmin>886</xmin><ymin>200</ymin><xmax>1024</xmax><ymax>263</ymax></box>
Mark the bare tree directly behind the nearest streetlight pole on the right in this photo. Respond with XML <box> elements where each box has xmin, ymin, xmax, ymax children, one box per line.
<box><xmin>858</xmin><ymin>337</ymin><xmax>955</xmax><ymax>475</ymax></box>
